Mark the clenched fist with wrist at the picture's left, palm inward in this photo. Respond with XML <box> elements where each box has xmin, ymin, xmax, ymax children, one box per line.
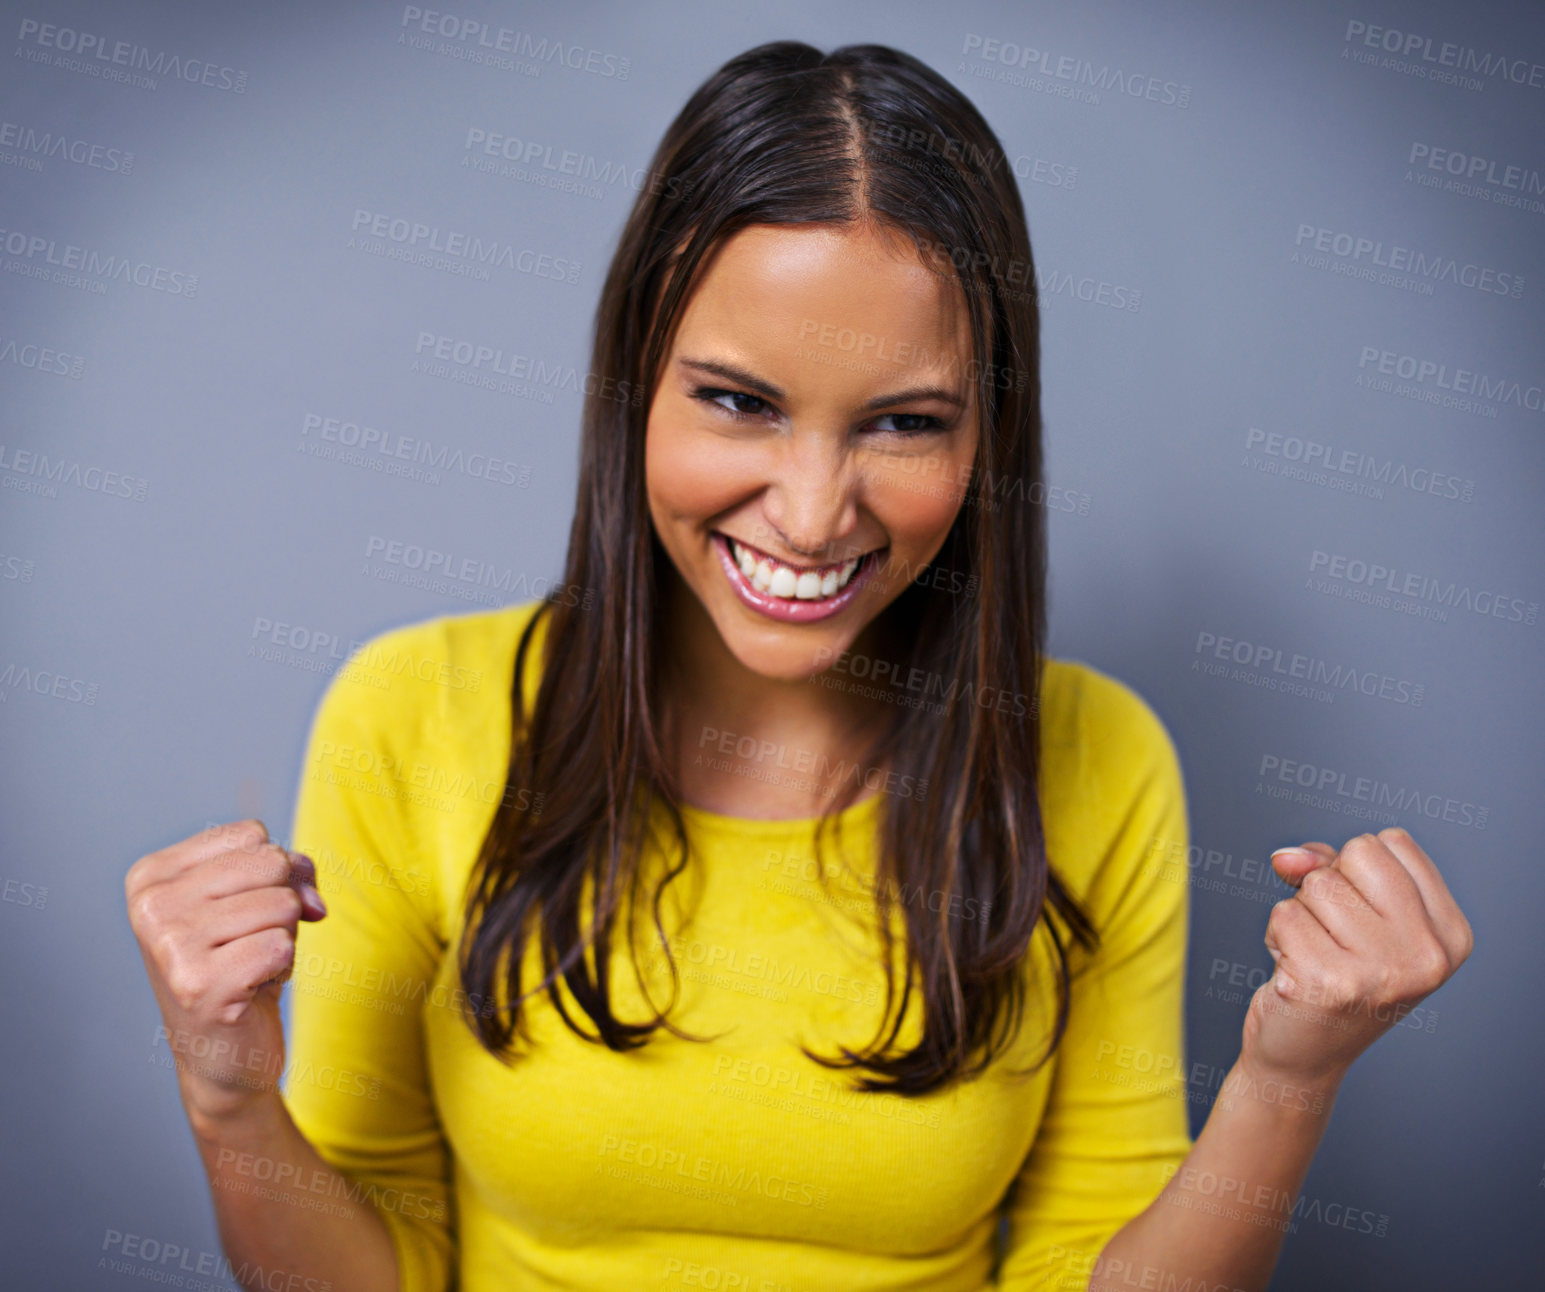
<box><xmin>124</xmin><ymin>819</ymin><xmax>328</xmax><ymax>1117</ymax></box>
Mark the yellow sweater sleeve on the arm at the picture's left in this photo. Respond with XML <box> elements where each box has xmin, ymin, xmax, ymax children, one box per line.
<box><xmin>284</xmin><ymin>624</ymin><xmax>456</xmax><ymax>1292</ymax></box>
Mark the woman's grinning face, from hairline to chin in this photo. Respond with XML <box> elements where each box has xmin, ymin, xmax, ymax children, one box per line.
<box><xmin>644</xmin><ymin>224</ymin><xmax>978</xmax><ymax>680</ymax></box>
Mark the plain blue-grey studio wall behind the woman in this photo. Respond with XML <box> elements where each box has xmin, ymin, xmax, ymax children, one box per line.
<box><xmin>0</xmin><ymin>0</ymin><xmax>1545</xmax><ymax>1292</ymax></box>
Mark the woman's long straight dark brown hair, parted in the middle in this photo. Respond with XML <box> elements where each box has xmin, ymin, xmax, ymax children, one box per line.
<box><xmin>459</xmin><ymin>40</ymin><xmax>1097</xmax><ymax>1094</ymax></box>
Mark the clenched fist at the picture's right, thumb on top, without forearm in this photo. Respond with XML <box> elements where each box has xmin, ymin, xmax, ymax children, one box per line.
<box><xmin>1241</xmin><ymin>825</ymin><xmax>1475</xmax><ymax>1085</ymax></box>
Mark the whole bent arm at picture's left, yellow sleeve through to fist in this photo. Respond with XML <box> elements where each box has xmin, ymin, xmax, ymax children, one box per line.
<box><xmin>134</xmin><ymin>621</ymin><xmax>463</xmax><ymax>1292</ymax></box>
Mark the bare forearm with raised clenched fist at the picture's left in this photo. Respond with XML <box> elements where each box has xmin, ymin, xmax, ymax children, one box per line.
<box><xmin>124</xmin><ymin>821</ymin><xmax>397</xmax><ymax>1292</ymax></box>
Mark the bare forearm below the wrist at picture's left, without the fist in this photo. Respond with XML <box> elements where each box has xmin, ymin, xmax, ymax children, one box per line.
<box><xmin>188</xmin><ymin>1091</ymin><xmax>397</xmax><ymax>1292</ymax></box>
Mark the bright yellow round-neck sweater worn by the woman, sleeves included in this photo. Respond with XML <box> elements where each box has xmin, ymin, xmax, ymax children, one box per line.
<box><xmin>284</xmin><ymin>601</ymin><xmax>1191</xmax><ymax>1292</ymax></box>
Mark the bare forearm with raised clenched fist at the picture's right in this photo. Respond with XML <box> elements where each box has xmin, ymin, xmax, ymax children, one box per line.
<box><xmin>1088</xmin><ymin>827</ymin><xmax>1474</xmax><ymax>1292</ymax></box>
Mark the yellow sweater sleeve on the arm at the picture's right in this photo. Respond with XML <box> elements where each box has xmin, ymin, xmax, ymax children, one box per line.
<box><xmin>997</xmin><ymin>671</ymin><xmax>1191</xmax><ymax>1292</ymax></box>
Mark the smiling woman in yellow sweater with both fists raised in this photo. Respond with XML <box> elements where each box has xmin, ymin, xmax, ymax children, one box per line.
<box><xmin>127</xmin><ymin>42</ymin><xmax>1471</xmax><ymax>1292</ymax></box>
